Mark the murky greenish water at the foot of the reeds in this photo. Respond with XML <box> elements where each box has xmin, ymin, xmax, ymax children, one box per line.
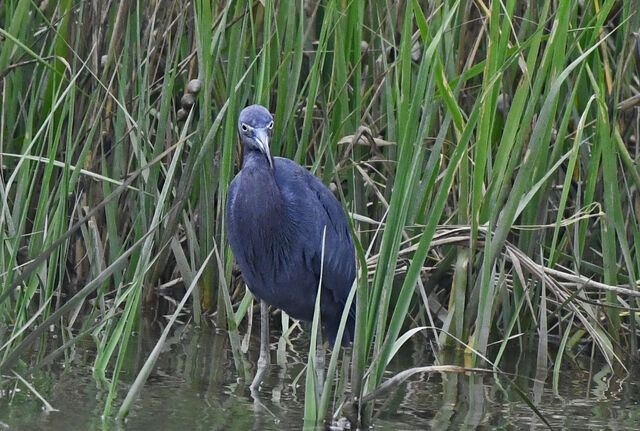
<box><xmin>0</xmin><ymin>326</ymin><xmax>640</xmax><ymax>430</ymax></box>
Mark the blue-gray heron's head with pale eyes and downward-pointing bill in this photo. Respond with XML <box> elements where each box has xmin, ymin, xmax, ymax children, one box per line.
<box><xmin>238</xmin><ymin>105</ymin><xmax>273</xmax><ymax>169</ymax></box>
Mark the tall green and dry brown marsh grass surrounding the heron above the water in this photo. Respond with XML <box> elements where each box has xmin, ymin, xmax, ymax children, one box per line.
<box><xmin>0</xmin><ymin>0</ymin><xmax>640</xmax><ymax>423</ymax></box>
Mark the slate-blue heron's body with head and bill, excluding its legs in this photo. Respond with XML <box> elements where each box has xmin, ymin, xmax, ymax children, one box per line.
<box><xmin>227</xmin><ymin>105</ymin><xmax>355</xmax><ymax>346</ymax></box>
